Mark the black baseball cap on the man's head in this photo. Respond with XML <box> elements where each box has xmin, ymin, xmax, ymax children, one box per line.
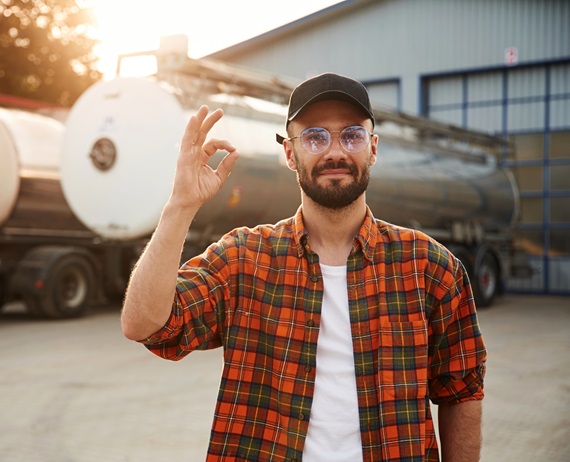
<box><xmin>286</xmin><ymin>72</ymin><xmax>374</xmax><ymax>126</ymax></box>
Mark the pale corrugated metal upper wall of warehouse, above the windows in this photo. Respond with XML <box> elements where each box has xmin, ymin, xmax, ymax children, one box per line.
<box><xmin>213</xmin><ymin>0</ymin><xmax>570</xmax><ymax>113</ymax></box>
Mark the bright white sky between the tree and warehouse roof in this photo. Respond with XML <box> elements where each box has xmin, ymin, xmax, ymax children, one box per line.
<box><xmin>91</xmin><ymin>0</ymin><xmax>340</xmax><ymax>78</ymax></box>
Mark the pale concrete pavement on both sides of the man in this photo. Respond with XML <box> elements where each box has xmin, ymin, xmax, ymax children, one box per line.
<box><xmin>0</xmin><ymin>295</ymin><xmax>570</xmax><ymax>462</ymax></box>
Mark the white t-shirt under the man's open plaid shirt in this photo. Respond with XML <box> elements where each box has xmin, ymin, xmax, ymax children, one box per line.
<box><xmin>303</xmin><ymin>264</ymin><xmax>362</xmax><ymax>462</ymax></box>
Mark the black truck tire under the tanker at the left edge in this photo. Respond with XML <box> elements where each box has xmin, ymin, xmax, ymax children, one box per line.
<box><xmin>37</xmin><ymin>253</ymin><xmax>95</xmax><ymax>318</ymax></box>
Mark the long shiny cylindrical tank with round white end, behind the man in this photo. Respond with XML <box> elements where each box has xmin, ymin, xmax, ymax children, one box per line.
<box><xmin>61</xmin><ymin>78</ymin><xmax>516</xmax><ymax>240</ymax></box>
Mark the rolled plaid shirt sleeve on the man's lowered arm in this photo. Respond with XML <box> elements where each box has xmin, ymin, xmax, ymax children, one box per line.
<box><xmin>428</xmin><ymin>249</ymin><xmax>487</xmax><ymax>404</ymax></box>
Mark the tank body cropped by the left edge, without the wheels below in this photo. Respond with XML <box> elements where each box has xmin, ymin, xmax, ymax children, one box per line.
<box><xmin>0</xmin><ymin>108</ymin><xmax>86</xmax><ymax>234</ymax></box>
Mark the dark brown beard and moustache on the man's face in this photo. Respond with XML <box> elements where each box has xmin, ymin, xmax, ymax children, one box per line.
<box><xmin>295</xmin><ymin>155</ymin><xmax>370</xmax><ymax>210</ymax></box>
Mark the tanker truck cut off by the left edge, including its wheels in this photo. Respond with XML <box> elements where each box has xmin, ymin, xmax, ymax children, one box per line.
<box><xmin>0</xmin><ymin>108</ymin><xmax>149</xmax><ymax>318</ymax></box>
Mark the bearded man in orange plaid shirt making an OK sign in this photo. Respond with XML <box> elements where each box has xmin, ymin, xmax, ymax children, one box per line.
<box><xmin>122</xmin><ymin>74</ymin><xmax>486</xmax><ymax>462</ymax></box>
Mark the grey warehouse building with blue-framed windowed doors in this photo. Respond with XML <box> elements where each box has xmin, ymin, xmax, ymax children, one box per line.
<box><xmin>210</xmin><ymin>0</ymin><xmax>570</xmax><ymax>294</ymax></box>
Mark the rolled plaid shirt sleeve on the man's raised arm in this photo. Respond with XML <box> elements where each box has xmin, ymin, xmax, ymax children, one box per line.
<box><xmin>137</xmin><ymin>240</ymin><xmax>230</xmax><ymax>361</ymax></box>
